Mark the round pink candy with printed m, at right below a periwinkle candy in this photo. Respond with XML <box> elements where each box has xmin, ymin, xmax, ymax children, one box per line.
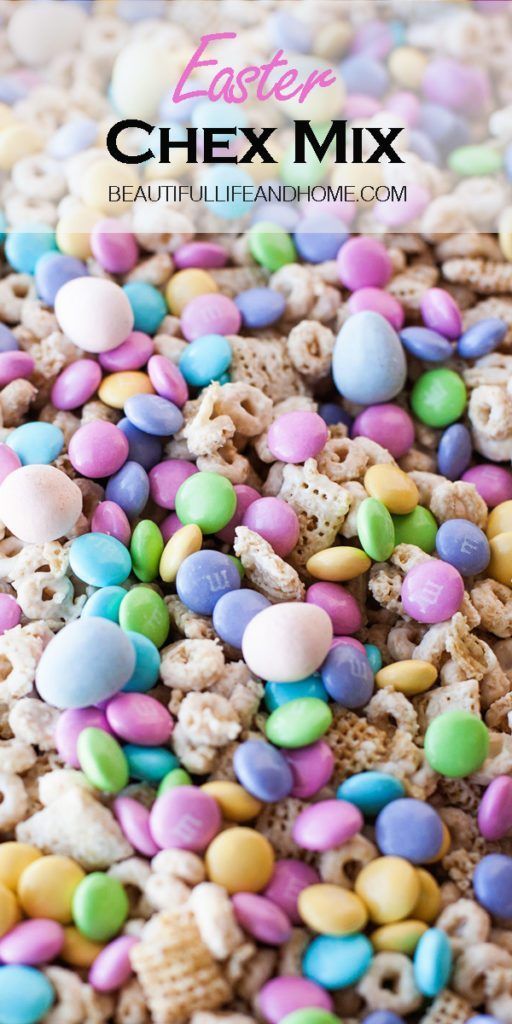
<box><xmin>401</xmin><ymin>558</ymin><xmax>464</xmax><ymax>624</ymax></box>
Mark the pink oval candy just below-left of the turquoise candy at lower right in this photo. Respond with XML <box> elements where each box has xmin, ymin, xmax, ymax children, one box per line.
<box><xmin>292</xmin><ymin>800</ymin><xmax>365</xmax><ymax>851</ymax></box>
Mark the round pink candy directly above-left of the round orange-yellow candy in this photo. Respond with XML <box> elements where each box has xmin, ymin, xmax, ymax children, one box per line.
<box><xmin>150</xmin><ymin>785</ymin><xmax>222</xmax><ymax>853</ymax></box>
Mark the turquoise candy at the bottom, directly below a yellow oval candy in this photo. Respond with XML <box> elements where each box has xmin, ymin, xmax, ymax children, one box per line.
<box><xmin>302</xmin><ymin>934</ymin><xmax>374</xmax><ymax>990</ymax></box>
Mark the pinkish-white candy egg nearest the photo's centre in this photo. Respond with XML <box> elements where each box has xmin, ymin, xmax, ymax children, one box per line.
<box><xmin>242</xmin><ymin>601</ymin><xmax>333</xmax><ymax>683</ymax></box>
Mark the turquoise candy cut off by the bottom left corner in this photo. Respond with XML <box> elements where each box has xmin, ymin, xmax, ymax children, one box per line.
<box><xmin>0</xmin><ymin>964</ymin><xmax>55</xmax><ymax>1024</ymax></box>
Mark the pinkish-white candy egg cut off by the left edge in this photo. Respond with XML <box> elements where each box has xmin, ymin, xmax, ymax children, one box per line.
<box><xmin>0</xmin><ymin>465</ymin><xmax>82</xmax><ymax>544</ymax></box>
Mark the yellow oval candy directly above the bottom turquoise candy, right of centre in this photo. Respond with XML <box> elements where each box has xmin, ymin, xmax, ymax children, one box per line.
<box><xmin>297</xmin><ymin>883</ymin><xmax>368</xmax><ymax>935</ymax></box>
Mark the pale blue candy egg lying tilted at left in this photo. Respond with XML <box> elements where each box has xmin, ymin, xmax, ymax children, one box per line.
<box><xmin>36</xmin><ymin>616</ymin><xmax>135</xmax><ymax>709</ymax></box>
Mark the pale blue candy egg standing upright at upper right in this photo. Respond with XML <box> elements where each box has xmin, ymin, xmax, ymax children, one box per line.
<box><xmin>333</xmin><ymin>310</ymin><xmax>407</xmax><ymax>406</ymax></box>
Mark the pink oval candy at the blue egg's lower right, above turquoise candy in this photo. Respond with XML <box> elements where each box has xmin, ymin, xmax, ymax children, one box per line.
<box><xmin>106</xmin><ymin>693</ymin><xmax>174</xmax><ymax>746</ymax></box>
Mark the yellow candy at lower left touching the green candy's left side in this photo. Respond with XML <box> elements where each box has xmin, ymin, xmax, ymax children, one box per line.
<box><xmin>17</xmin><ymin>854</ymin><xmax>85</xmax><ymax>925</ymax></box>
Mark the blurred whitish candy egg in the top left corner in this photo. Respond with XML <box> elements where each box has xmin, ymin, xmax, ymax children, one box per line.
<box><xmin>7</xmin><ymin>0</ymin><xmax>86</xmax><ymax>68</ymax></box>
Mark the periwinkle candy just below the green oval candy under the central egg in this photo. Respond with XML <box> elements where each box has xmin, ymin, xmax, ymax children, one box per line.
<box><xmin>232</xmin><ymin>739</ymin><xmax>294</xmax><ymax>804</ymax></box>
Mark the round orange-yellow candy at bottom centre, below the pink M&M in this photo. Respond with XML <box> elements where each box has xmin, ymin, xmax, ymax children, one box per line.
<box><xmin>205</xmin><ymin>827</ymin><xmax>274</xmax><ymax>894</ymax></box>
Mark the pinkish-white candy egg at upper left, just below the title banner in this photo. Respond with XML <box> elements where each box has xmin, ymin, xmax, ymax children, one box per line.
<box><xmin>55</xmin><ymin>278</ymin><xmax>134</xmax><ymax>352</ymax></box>
